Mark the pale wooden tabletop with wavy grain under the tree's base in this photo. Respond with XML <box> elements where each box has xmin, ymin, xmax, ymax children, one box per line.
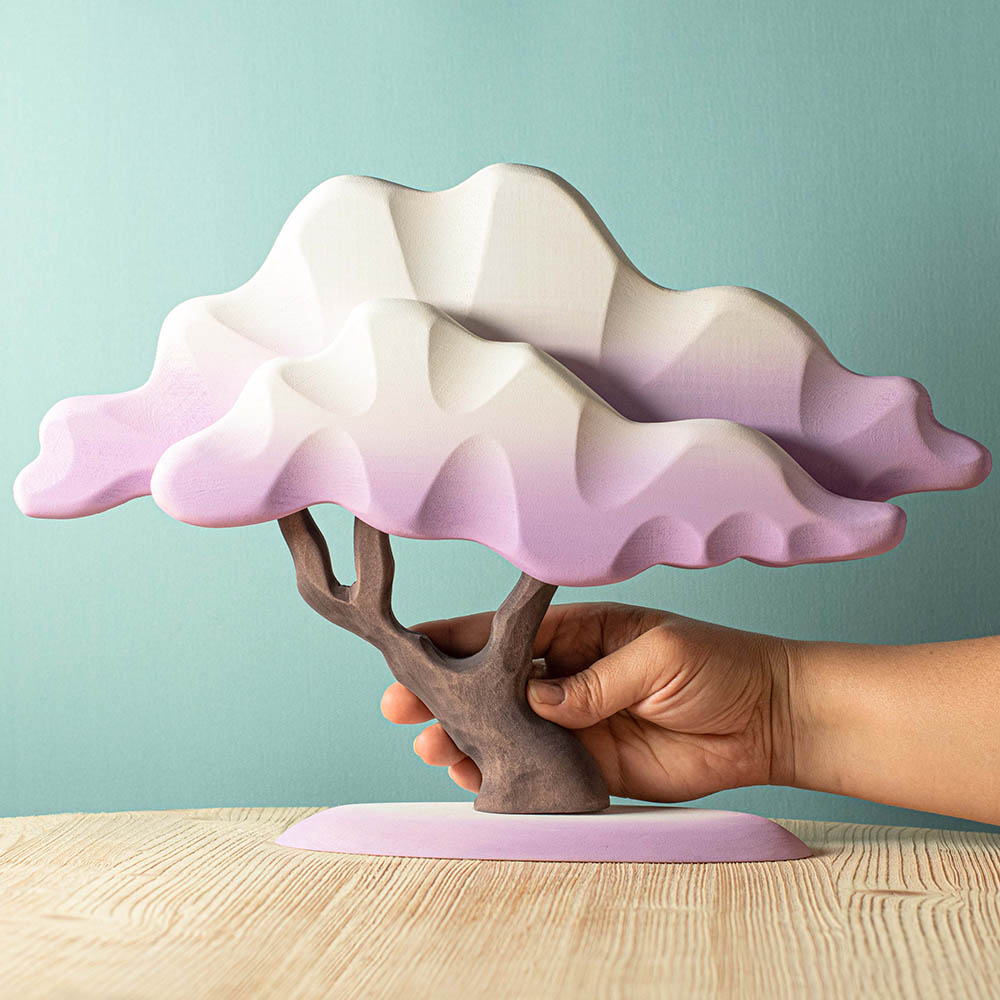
<box><xmin>0</xmin><ymin>809</ymin><xmax>1000</xmax><ymax>1000</ymax></box>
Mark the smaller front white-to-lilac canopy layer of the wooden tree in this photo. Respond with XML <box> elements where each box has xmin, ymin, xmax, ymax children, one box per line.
<box><xmin>152</xmin><ymin>299</ymin><xmax>905</xmax><ymax>586</ymax></box>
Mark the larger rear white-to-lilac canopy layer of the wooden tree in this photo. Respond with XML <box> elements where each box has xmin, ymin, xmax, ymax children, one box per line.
<box><xmin>14</xmin><ymin>164</ymin><xmax>990</xmax><ymax>517</ymax></box>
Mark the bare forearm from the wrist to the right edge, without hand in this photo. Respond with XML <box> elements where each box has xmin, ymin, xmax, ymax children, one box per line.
<box><xmin>788</xmin><ymin>637</ymin><xmax>1000</xmax><ymax>823</ymax></box>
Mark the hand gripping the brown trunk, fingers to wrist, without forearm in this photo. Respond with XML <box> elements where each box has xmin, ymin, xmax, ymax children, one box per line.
<box><xmin>382</xmin><ymin>604</ymin><xmax>794</xmax><ymax>802</ymax></box>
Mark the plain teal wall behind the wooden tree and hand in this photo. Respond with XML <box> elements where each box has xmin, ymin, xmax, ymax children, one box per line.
<box><xmin>0</xmin><ymin>0</ymin><xmax>1000</xmax><ymax>826</ymax></box>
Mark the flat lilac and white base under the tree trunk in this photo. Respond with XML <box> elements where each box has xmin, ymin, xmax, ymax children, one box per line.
<box><xmin>277</xmin><ymin>802</ymin><xmax>812</xmax><ymax>861</ymax></box>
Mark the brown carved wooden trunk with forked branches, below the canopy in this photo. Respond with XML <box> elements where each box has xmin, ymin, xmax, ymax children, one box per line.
<box><xmin>278</xmin><ymin>510</ymin><xmax>609</xmax><ymax>813</ymax></box>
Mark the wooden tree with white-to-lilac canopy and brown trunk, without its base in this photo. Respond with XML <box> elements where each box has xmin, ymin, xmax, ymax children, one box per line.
<box><xmin>15</xmin><ymin>164</ymin><xmax>990</xmax><ymax>856</ymax></box>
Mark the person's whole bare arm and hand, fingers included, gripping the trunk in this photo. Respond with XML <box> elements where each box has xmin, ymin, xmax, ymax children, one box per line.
<box><xmin>383</xmin><ymin>604</ymin><xmax>1000</xmax><ymax>823</ymax></box>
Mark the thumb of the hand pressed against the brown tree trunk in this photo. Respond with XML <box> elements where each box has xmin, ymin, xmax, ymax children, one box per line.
<box><xmin>528</xmin><ymin>630</ymin><xmax>664</xmax><ymax>729</ymax></box>
